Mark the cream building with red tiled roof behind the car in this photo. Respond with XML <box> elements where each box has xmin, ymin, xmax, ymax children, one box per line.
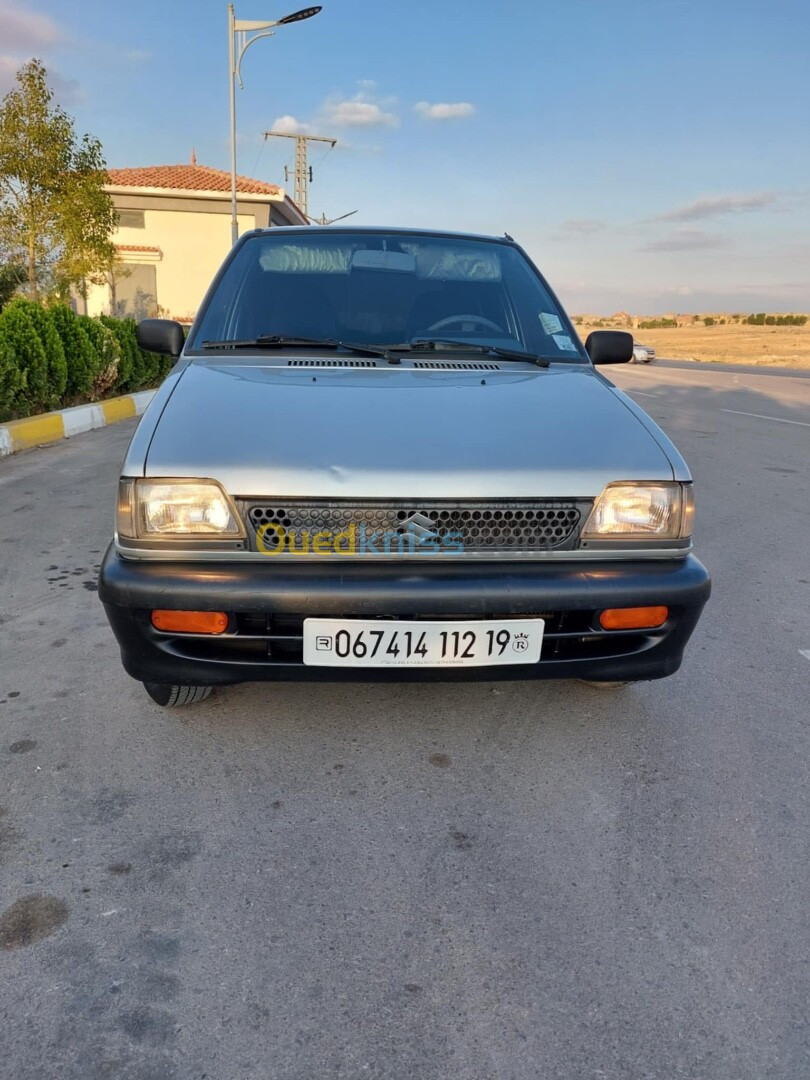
<box><xmin>78</xmin><ymin>153</ymin><xmax>309</xmax><ymax>322</ymax></box>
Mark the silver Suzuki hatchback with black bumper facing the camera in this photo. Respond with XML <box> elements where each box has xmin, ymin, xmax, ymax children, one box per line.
<box><xmin>99</xmin><ymin>228</ymin><xmax>710</xmax><ymax>705</ymax></box>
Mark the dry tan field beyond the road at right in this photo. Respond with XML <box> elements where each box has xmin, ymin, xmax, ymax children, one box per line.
<box><xmin>577</xmin><ymin>323</ymin><xmax>810</xmax><ymax>367</ymax></box>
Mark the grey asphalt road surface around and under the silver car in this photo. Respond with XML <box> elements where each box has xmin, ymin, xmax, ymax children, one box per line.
<box><xmin>0</xmin><ymin>365</ymin><xmax>810</xmax><ymax>1080</ymax></box>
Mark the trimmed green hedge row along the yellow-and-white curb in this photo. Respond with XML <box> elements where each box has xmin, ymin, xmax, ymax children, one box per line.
<box><xmin>0</xmin><ymin>298</ymin><xmax>173</xmax><ymax>421</ymax></box>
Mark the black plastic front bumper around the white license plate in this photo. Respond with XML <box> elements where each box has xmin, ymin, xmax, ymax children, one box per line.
<box><xmin>98</xmin><ymin>545</ymin><xmax>711</xmax><ymax>686</ymax></box>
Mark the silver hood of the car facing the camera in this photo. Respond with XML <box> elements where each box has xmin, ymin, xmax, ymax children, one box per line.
<box><xmin>141</xmin><ymin>357</ymin><xmax>673</xmax><ymax>499</ymax></box>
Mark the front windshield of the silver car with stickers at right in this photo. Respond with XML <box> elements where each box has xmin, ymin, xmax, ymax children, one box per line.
<box><xmin>189</xmin><ymin>229</ymin><xmax>588</xmax><ymax>363</ymax></box>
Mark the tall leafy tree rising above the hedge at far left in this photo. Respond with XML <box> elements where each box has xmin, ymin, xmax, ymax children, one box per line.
<box><xmin>0</xmin><ymin>59</ymin><xmax>116</xmax><ymax>299</ymax></box>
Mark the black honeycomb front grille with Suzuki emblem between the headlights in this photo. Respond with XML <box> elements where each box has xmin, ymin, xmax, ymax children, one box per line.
<box><xmin>240</xmin><ymin>499</ymin><xmax>592</xmax><ymax>556</ymax></box>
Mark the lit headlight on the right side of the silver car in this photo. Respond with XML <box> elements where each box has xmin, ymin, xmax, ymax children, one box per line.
<box><xmin>581</xmin><ymin>483</ymin><xmax>694</xmax><ymax>540</ymax></box>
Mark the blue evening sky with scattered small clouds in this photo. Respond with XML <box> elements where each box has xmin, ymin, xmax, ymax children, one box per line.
<box><xmin>0</xmin><ymin>0</ymin><xmax>810</xmax><ymax>314</ymax></box>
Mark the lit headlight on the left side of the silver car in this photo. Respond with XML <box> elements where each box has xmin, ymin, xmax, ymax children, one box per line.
<box><xmin>117</xmin><ymin>480</ymin><xmax>244</xmax><ymax>540</ymax></box>
